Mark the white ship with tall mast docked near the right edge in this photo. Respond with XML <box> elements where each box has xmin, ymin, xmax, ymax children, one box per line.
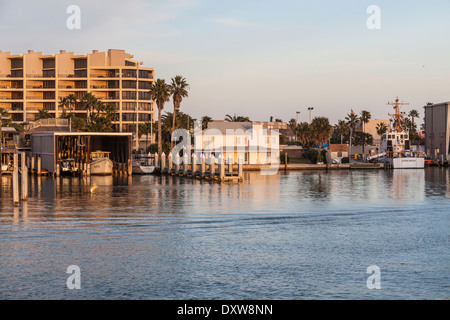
<box><xmin>377</xmin><ymin>98</ymin><xmax>425</xmax><ymax>169</ymax></box>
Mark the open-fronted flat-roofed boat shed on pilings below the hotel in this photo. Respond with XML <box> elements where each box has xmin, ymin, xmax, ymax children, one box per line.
<box><xmin>30</xmin><ymin>132</ymin><xmax>132</xmax><ymax>174</ymax></box>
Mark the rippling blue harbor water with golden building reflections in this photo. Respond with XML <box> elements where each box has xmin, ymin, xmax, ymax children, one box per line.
<box><xmin>0</xmin><ymin>168</ymin><xmax>450</xmax><ymax>299</ymax></box>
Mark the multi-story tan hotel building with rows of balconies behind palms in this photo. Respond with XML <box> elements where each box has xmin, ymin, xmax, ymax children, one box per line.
<box><xmin>0</xmin><ymin>49</ymin><xmax>154</xmax><ymax>132</ymax></box>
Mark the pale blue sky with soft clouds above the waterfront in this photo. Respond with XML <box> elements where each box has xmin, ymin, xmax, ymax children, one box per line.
<box><xmin>0</xmin><ymin>0</ymin><xmax>450</xmax><ymax>124</ymax></box>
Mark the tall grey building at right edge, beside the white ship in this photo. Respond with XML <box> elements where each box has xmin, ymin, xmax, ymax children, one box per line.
<box><xmin>424</xmin><ymin>102</ymin><xmax>450</xmax><ymax>161</ymax></box>
